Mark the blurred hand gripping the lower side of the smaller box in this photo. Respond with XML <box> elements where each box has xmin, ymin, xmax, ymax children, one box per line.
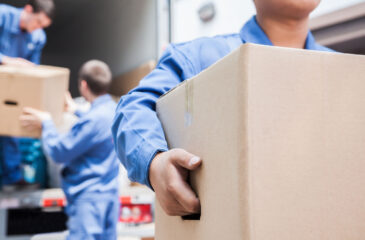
<box><xmin>19</xmin><ymin>108</ymin><xmax>52</xmax><ymax>131</ymax></box>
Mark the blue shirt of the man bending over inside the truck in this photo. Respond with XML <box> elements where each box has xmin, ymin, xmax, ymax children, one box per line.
<box><xmin>0</xmin><ymin>4</ymin><xmax>47</xmax><ymax>64</ymax></box>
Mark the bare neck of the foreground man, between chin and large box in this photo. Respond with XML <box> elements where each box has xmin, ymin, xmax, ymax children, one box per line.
<box><xmin>256</xmin><ymin>15</ymin><xmax>309</xmax><ymax>48</ymax></box>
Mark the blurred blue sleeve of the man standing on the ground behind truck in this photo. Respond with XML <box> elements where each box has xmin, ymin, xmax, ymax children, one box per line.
<box><xmin>42</xmin><ymin>117</ymin><xmax>95</xmax><ymax>164</ymax></box>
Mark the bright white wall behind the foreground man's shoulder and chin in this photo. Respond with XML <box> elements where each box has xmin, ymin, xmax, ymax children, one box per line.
<box><xmin>172</xmin><ymin>0</ymin><xmax>365</xmax><ymax>42</ymax></box>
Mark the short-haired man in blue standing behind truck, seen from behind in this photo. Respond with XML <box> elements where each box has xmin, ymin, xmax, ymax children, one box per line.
<box><xmin>21</xmin><ymin>60</ymin><xmax>119</xmax><ymax>240</ymax></box>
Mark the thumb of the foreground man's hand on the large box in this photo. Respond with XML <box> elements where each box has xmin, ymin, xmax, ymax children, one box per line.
<box><xmin>170</xmin><ymin>149</ymin><xmax>202</xmax><ymax>170</ymax></box>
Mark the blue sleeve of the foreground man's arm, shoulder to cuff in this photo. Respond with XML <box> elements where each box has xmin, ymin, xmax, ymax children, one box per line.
<box><xmin>112</xmin><ymin>45</ymin><xmax>193</xmax><ymax>187</ymax></box>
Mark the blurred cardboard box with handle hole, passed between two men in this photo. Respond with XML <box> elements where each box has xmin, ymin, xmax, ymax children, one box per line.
<box><xmin>0</xmin><ymin>66</ymin><xmax>70</xmax><ymax>137</ymax></box>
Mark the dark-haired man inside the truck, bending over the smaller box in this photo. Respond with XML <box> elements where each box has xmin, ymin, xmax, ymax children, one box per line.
<box><xmin>0</xmin><ymin>0</ymin><xmax>55</xmax><ymax>191</ymax></box>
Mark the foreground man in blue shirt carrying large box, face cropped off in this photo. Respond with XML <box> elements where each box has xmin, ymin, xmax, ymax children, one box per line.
<box><xmin>112</xmin><ymin>0</ymin><xmax>330</xmax><ymax>215</ymax></box>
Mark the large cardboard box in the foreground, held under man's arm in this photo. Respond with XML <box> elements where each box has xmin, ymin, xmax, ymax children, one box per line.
<box><xmin>156</xmin><ymin>44</ymin><xmax>365</xmax><ymax>240</ymax></box>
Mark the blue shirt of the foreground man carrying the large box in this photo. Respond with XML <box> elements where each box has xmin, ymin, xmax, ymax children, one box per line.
<box><xmin>112</xmin><ymin>17</ymin><xmax>332</xmax><ymax>186</ymax></box>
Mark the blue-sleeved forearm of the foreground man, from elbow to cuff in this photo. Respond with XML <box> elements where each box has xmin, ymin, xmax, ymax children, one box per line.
<box><xmin>113</xmin><ymin>93</ymin><xmax>167</xmax><ymax>186</ymax></box>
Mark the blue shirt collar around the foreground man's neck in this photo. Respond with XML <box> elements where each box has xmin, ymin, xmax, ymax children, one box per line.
<box><xmin>240</xmin><ymin>16</ymin><xmax>317</xmax><ymax>50</ymax></box>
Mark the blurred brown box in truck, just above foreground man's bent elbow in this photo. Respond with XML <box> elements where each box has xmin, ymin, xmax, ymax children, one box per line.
<box><xmin>109</xmin><ymin>60</ymin><xmax>156</xmax><ymax>97</ymax></box>
